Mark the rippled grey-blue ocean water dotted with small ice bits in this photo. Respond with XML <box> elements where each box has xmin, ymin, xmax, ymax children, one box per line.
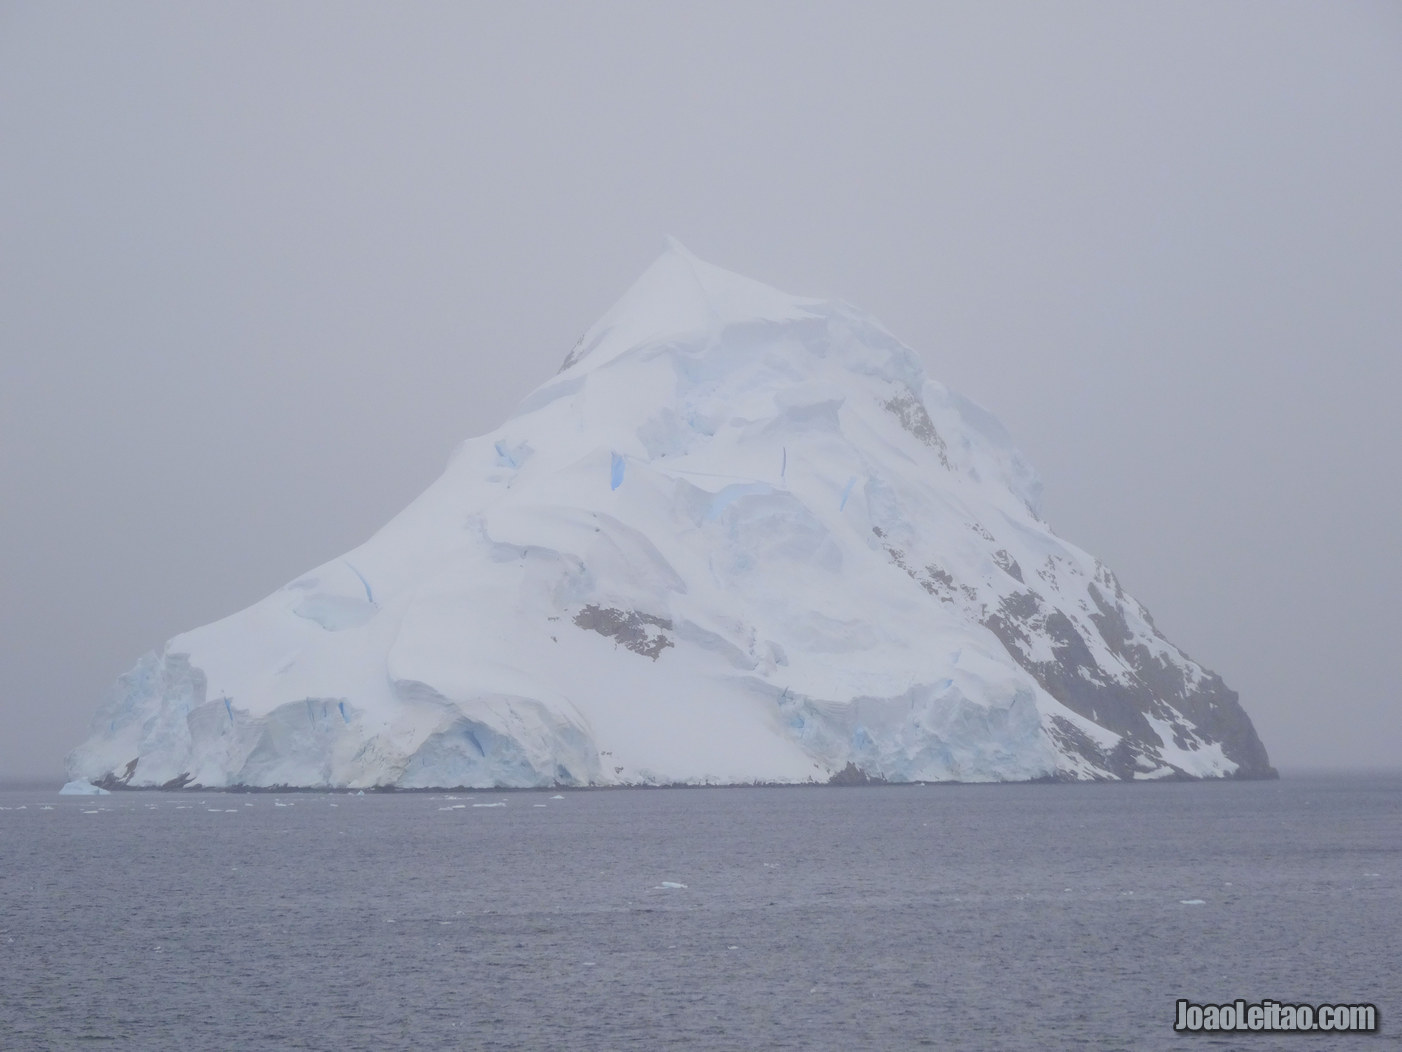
<box><xmin>0</xmin><ymin>776</ymin><xmax>1402</xmax><ymax>1052</ymax></box>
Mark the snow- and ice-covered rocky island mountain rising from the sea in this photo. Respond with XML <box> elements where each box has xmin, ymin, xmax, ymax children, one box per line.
<box><xmin>67</xmin><ymin>243</ymin><xmax>1274</xmax><ymax>788</ymax></box>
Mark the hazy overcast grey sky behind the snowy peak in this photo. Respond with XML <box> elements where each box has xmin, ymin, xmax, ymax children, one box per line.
<box><xmin>0</xmin><ymin>0</ymin><xmax>1402</xmax><ymax>780</ymax></box>
